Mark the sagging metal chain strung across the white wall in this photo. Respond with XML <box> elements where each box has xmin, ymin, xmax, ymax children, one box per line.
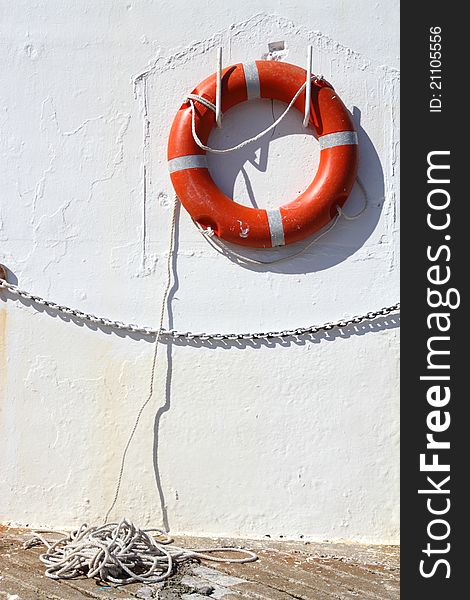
<box><xmin>0</xmin><ymin>279</ymin><xmax>400</xmax><ymax>341</ymax></box>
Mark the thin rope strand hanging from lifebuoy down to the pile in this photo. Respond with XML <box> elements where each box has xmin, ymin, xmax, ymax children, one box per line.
<box><xmin>104</xmin><ymin>196</ymin><xmax>178</xmax><ymax>525</ymax></box>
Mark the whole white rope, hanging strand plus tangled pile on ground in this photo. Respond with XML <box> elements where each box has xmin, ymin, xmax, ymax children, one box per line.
<box><xmin>25</xmin><ymin>196</ymin><xmax>258</xmax><ymax>585</ymax></box>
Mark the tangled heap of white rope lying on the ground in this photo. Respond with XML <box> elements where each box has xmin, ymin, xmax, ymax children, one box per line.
<box><xmin>24</xmin><ymin>519</ymin><xmax>258</xmax><ymax>585</ymax></box>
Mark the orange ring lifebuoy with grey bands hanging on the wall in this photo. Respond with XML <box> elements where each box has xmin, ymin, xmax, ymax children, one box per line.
<box><xmin>168</xmin><ymin>60</ymin><xmax>358</xmax><ymax>248</ymax></box>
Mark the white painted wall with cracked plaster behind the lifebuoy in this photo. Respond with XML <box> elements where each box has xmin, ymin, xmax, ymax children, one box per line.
<box><xmin>0</xmin><ymin>0</ymin><xmax>398</xmax><ymax>542</ymax></box>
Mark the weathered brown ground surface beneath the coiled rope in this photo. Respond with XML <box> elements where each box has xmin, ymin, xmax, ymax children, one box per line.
<box><xmin>0</xmin><ymin>528</ymin><xmax>399</xmax><ymax>600</ymax></box>
